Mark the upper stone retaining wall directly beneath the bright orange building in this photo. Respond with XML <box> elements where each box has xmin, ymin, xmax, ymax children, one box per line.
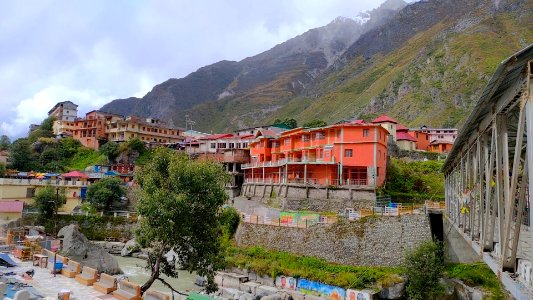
<box><xmin>242</xmin><ymin>184</ymin><xmax>376</xmax><ymax>212</ymax></box>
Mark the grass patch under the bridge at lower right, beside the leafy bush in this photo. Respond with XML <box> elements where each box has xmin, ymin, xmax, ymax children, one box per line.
<box><xmin>445</xmin><ymin>263</ymin><xmax>504</xmax><ymax>299</ymax></box>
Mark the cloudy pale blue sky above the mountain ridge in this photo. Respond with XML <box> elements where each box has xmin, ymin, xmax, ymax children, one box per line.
<box><xmin>0</xmin><ymin>0</ymin><xmax>383</xmax><ymax>139</ymax></box>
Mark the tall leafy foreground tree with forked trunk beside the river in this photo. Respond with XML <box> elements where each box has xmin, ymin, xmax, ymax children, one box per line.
<box><xmin>135</xmin><ymin>147</ymin><xmax>228</xmax><ymax>293</ymax></box>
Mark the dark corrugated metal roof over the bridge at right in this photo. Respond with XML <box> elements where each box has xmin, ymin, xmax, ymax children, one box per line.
<box><xmin>442</xmin><ymin>44</ymin><xmax>533</xmax><ymax>172</ymax></box>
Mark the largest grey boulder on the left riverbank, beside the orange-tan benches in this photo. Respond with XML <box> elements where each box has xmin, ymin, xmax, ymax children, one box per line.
<box><xmin>57</xmin><ymin>224</ymin><xmax>123</xmax><ymax>275</ymax></box>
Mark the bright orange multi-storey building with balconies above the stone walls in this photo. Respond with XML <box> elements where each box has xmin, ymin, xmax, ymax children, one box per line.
<box><xmin>242</xmin><ymin>123</ymin><xmax>389</xmax><ymax>187</ymax></box>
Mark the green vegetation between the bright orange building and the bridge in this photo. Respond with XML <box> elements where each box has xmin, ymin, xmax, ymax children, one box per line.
<box><xmin>384</xmin><ymin>158</ymin><xmax>444</xmax><ymax>202</ymax></box>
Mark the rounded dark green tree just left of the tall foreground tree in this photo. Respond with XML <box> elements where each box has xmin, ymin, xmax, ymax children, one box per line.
<box><xmin>87</xmin><ymin>177</ymin><xmax>126</xmax><ymax>211</ymax></box>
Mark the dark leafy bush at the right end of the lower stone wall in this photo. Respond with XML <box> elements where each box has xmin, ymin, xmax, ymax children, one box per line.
<box><xmin>405</xmin><ymin>240</ymin><xmax>444</xmax><ymax>300</ymax></box>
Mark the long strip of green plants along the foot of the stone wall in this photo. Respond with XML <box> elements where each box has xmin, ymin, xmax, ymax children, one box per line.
<box><xmin>222</xmin><ymin>247</ymin><xmax>402</xmax><ymax>289</ymax></box>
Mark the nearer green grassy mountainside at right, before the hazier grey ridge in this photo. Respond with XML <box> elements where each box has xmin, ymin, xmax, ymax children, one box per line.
<box><xmin>274</xmin><ymin>2</ymin><xmax>533</xmax><ymax>126</ymax></box>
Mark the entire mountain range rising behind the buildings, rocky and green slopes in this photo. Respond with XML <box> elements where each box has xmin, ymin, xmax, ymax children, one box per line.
<box><xmin>102</xmin><ymin>0</ymin><xmax>533</xmax><ymax>131</ymax></box>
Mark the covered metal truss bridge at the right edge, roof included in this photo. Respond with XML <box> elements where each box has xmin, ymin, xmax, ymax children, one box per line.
<box><xmin>443</xmin><ymin>44</ymin><xmax>533</xmax><ymax>299</ymax></box>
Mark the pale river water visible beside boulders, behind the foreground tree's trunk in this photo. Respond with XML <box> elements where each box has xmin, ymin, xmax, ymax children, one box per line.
<box><xmin>115</xmin><ymin>256</ymin><xmax>202</xmax><ymax>294</ymax></box>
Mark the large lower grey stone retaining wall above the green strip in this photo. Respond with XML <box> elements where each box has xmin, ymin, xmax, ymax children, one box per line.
<box><xmin>236</xmin><ymin>215</ymin><xmax>431</xmax><ymax>266</ymax></box>
